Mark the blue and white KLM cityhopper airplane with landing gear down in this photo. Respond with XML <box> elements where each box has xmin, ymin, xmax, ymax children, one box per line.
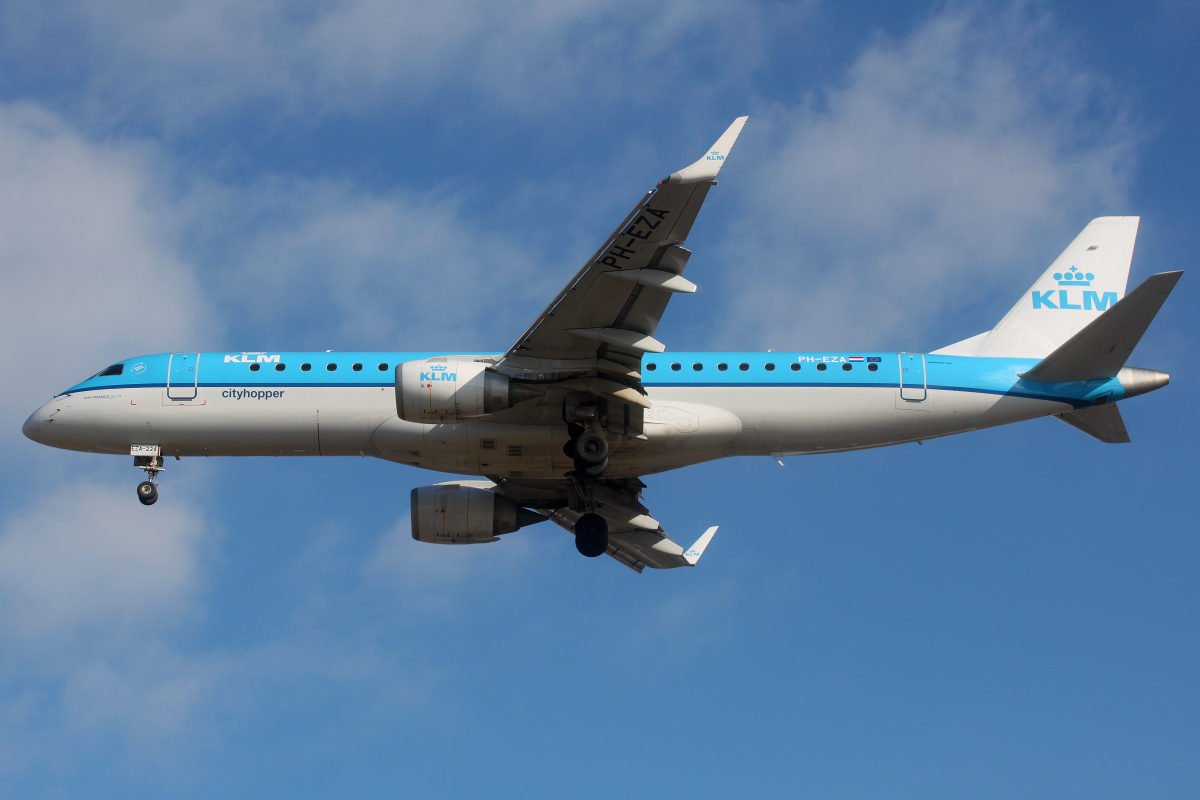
<box><xmin>24</xmin><ymin>116</ymin><xmax>1182</xmax><ymax>572</ymax></box>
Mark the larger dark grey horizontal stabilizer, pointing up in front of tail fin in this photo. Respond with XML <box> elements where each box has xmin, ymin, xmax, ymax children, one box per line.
<box><xmin>1021</xmin><ymin>272</ymin><xmax>1183</xmax><ymax>383</ymax></box>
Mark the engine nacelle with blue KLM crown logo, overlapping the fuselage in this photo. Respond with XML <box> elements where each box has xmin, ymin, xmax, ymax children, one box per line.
<box><xmin>396</xmin><ymin>359</ymin><xmax>545</xmax><ymax>422</ymax></box>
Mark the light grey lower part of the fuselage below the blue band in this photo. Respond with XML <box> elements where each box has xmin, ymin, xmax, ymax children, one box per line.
<box><xmin>39</xmin><ymin>386</ymin><xmax>1072</xmax><ymax>479</ymax></box>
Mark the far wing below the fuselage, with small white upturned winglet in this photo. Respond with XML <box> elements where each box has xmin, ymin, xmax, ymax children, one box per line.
<box><xmin>491</xmin><ymin>477</ymin><xmax>716</xmax><ymax>572</ymax></box>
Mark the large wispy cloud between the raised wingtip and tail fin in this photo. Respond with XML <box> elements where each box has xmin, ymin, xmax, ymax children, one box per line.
<box><xmin>722</xmin><ymin>6</ymin><xmax>1134</xmax><ymax>349</ymax></box>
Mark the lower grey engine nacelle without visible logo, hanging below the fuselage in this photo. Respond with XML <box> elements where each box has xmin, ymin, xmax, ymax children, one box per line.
<box><xmin>413</xmin><ymin>483</ymin><xmax>546</xmax><ymax>545</ymax></box>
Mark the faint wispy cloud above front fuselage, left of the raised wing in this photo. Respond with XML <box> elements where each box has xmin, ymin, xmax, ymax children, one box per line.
<box><xmin>186</xmin><ymin>178</ymin><xmax>568</xmax><ymax>350</ymax></box>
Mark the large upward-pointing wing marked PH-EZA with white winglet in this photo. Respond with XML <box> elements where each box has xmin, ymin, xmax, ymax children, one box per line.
<box><xmin>497</xmin><ymin>116</ymin><xmax>746</xmax><ymax>435</ymax></box>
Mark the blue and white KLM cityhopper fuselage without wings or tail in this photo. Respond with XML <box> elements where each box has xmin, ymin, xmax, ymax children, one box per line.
<box><xmin>25</xmin><ymin>351</ymin><xmax>1144</xmax><ymax>477</ymax></box>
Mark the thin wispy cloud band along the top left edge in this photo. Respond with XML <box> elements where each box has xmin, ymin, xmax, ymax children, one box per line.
<box><xmin>0</xmin><ymin>0</ymin><xmax>808</xmax><ymax>126</ymax></box>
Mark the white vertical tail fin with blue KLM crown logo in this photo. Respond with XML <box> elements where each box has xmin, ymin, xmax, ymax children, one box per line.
<box><xmin>935</xmin><ymin>217</ymin><xmax>1140</xmax><ymax>359</ymax></box>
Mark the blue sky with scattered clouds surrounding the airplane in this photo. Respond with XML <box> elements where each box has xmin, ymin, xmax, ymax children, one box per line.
<box><xmin>0</xmin><ymin>0</ymin><xmax>1200</xmax><ymax>799</ymax></box>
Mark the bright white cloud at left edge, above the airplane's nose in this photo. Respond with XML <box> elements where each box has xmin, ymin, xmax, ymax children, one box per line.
<box><xmin>0</xmin><ymin>104</ymin><xmax>212</xmax><ymax>453</ymax></box>
